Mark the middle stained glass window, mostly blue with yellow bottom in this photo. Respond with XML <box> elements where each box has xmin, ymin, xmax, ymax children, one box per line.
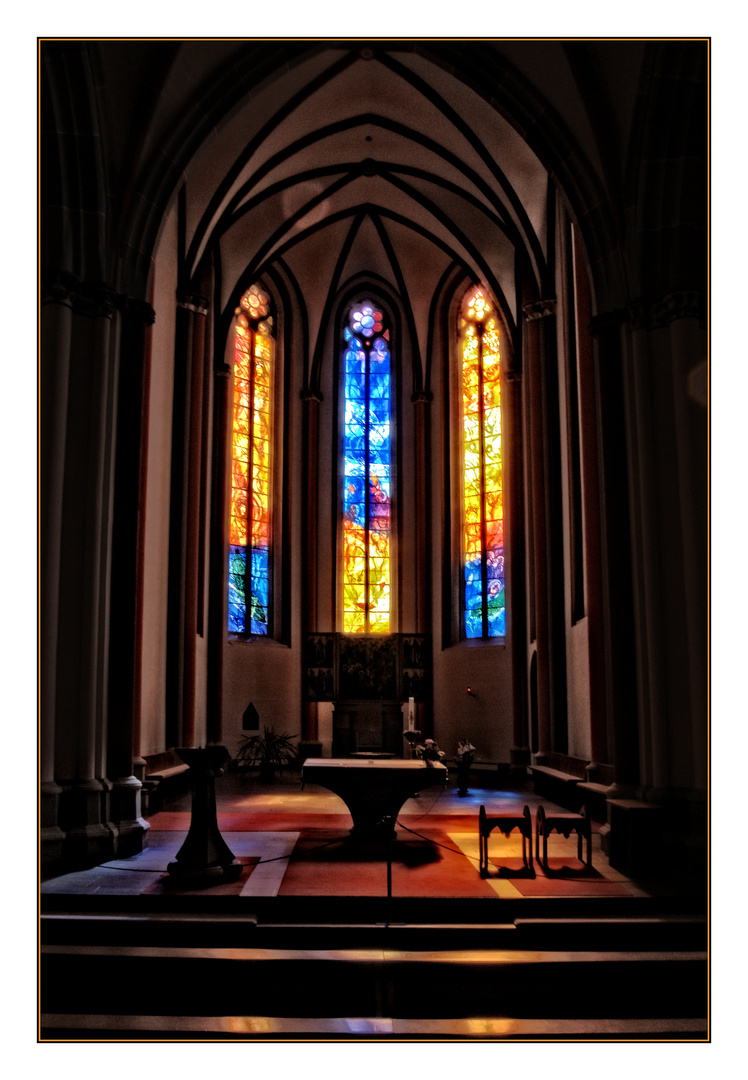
<box><xmin>342</xmin><ymin>301</ymin><xmax>392</xmax><ymax>634</ymax></box>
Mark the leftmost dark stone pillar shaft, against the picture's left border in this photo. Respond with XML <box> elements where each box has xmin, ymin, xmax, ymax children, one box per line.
<box><xmin>39</xmin><ymin>274</ymin><xmax>74</xmax><ymax>858</ymax></box>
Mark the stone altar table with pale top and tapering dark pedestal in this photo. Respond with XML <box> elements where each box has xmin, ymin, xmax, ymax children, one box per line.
<box><xmin>301</xmin><ymin>757</ymin><xmax>449</xmax><ymax>839</ymax></box>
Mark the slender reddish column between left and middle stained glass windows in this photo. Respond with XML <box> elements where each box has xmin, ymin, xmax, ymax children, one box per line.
<box><xmin>299</xmin><ymin>390</ymin><xmax>322</xmax><ymax>757</ymax></box>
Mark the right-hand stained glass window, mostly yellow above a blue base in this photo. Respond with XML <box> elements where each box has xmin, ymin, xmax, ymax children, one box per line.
<box><xmin>459</xmin><ymin>288</ymin><xmax>506</xmax><ymax>638</ymax></box>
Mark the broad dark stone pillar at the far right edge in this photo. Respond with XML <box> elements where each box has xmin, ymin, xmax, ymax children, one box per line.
<box><xmin>628</xmin><ymin>292</ymin><xmax>708</xmax><ymax>798</ymax></box>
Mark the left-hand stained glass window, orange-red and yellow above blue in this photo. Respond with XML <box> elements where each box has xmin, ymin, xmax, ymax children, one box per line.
<box><xmin>229</xmin><ymin>285</ymin><xmax>274</xmax><ymax>634</ymax></box>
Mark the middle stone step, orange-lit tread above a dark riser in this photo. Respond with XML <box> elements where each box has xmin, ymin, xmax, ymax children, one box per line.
<box><xmin>40</xmin><ymin>945</ymin><xmax>708</xmax><ymax>1020</ymax></box>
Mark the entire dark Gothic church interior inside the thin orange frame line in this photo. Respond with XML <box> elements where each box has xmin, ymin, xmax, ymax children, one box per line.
<box><xmin>39</xmin><ymin>38</ymin><xmax>709</xmax><ymax>1041</ymax></box>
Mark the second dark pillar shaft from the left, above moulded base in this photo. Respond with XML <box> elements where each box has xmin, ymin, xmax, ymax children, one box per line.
<box><xmin>55</xmin><ymin>285</ymin><xmax>118</xmax><ymax>862</ymax></box>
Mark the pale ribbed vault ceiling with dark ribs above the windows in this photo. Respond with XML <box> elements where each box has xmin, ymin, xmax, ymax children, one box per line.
<box><xmin>166</xmin><ymin>49</ymin><xmax>548</xmax><ymax>387</ymax></box>
